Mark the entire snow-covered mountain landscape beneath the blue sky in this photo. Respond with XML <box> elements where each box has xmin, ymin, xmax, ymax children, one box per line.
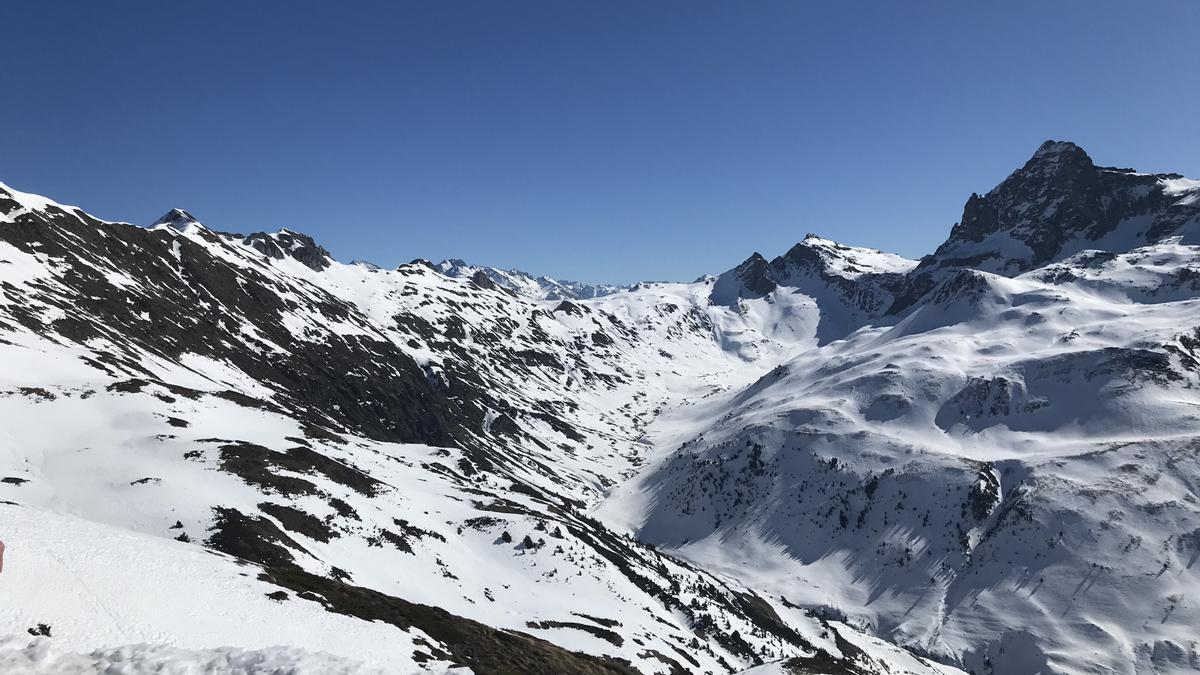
<box><xmin>0</xmin><ymin>142</ymin><xmax>1200</xmax><ymax>674</ymax></box>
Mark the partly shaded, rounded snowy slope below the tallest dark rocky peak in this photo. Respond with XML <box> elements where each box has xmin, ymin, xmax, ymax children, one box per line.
<box><xmin>601</xmin><ymin>147</ymin><xmax>1200</xmax><ymax>673</ymax></box>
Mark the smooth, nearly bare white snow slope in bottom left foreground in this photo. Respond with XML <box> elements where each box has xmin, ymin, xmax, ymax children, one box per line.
<box><xmin>0</xmin><ymin>503</ymin><xmax>448</xmax><ymax>673</ymax></box>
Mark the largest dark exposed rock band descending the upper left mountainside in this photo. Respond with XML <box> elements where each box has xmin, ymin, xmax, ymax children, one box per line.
<box><xmin>0</xmin><ymin>201</ymin><xmax>482</xmax><ymax>446</ymax></box>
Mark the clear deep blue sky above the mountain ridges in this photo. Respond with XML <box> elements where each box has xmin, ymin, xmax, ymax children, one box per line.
<box><xmin>0</xmin><ymin>0</ymin><xmax>1200</xmax><ymax>282</ymax></box>
